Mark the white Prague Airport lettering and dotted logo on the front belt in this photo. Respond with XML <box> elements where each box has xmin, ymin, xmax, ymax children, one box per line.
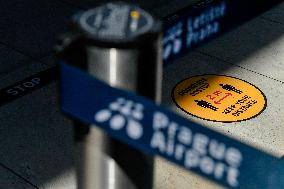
<box><xmin>94</xmin><ymin>97</ymin><xmax>243</xmax><ymax>187</ymax></box>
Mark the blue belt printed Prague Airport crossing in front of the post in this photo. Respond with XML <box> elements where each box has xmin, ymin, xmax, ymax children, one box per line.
<box><xmin>61</xmin><ymin>62</ymin><xmax>284</xmax><ymax>189</ymax></box>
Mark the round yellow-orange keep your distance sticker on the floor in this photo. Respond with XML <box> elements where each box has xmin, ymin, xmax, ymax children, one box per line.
<box><xmin>172</xmin><ymin>75</ymin><xmax>266</xmax><ymax>122</ymax></box>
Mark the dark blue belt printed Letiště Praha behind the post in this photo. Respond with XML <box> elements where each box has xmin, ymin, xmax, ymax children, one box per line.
<box><xmin>162</xmin><ymin>0</ymin><xmax>282</xmax><ymax>64</ymax></box>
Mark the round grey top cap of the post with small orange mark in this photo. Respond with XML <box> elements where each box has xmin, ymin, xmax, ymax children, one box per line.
<box><xmin>74</xmin><ymin>2</ymin><xmax>161</xmax><ymax>44</ymax></box>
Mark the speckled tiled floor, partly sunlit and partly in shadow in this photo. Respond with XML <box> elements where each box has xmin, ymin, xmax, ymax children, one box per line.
<box><xmin>0</xmin><ymin>0</ymin><xmax>284</xmax><ymax>189</ymax></box>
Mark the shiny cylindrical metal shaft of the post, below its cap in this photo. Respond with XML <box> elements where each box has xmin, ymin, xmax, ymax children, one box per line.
<box><xmin>75</xmin><ymin>38</ymin><xmax>162</xmax><ymax>189</ymax></box>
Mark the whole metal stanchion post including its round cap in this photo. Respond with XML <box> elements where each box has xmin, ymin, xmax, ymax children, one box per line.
<box><xmin>58</xmin><ymin>2</ymin><xmax>162</xmax><ymax>189</ymax></box>
